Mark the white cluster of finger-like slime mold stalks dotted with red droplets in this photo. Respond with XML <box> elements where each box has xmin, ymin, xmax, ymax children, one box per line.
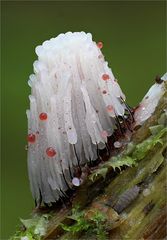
<box><xmin>27</xmin><ymin>32</ymin><xmax>132</xmax><ymax>206</ymax></box>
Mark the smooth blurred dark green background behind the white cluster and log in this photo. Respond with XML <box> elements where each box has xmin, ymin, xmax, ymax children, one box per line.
<box><xmin>0</xmin><ymin>1</ymin><xmax>166</xmax><ymax>239</ymax></box>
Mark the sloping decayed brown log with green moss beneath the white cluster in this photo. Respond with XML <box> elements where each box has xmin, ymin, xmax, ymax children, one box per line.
<box><xmin>11</xmin><ymin>81</ymin><xmax>167</xmax><ymax>240</ymax></box>
